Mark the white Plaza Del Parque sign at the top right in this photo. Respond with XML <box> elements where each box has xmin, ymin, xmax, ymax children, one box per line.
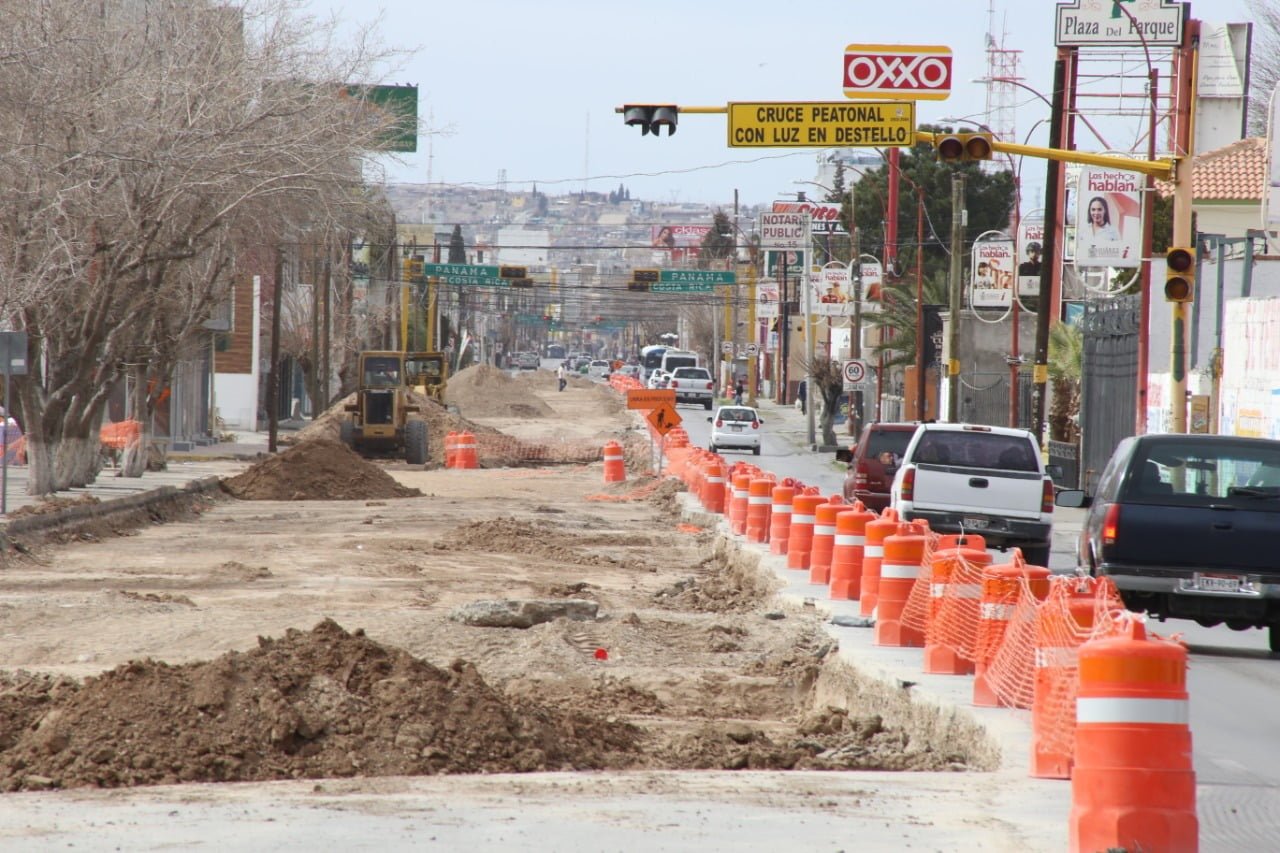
<box><xmin>1055</xmin><ymin>0</ymin><xmax>1189</xmax><ymax>47</ymax></box>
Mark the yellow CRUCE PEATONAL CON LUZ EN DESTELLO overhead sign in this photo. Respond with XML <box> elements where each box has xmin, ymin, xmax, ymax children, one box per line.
<box><xmin>728</xmin><ymin>101</ymin><xmax>915</xmax><ymax>149</ymax></box>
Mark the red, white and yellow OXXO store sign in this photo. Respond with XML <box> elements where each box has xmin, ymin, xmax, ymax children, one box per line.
<box><xmin>845</xmin><ymin>45</ymin><xmax>951</xmax><ymax>101</ymax></box>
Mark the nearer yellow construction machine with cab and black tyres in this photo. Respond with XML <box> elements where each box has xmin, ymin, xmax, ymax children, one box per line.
<box><xmin>340</xmin><ymin>352</ymin><xmax>432</xmax><ymax>465</ymax></box>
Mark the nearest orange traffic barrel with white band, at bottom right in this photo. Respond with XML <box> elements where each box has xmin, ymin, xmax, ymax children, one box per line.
<box><xmin>1068</xmin><ymin>615</ymin><xmax>1199</xmax><ymax>850</ymax></box>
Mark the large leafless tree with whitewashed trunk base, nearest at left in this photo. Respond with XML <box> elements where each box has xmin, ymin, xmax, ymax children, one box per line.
<box><xmin>0</xmin><ymin>0</ymin><xmax>404</xmax><ymax>494</ymax></box>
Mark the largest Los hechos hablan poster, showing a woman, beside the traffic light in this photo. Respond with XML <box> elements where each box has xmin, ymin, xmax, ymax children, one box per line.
<box><xmin>1075</xmin><ymin>167</ymin><xmax>1144</xmax><ymax>268</ymax></box>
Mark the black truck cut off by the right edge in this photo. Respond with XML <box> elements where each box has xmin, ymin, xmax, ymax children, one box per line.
<box><xmin>1057</xmin><ymin>434</ymin><xmax>1280</xmax><ymax>652</ymax></box>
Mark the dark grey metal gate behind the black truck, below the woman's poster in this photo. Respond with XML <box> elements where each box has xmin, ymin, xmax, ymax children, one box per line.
<box><xmin>1080</xmin><ymin>296</ymin><xmax>1142</xmax><ymax>494</ymax></box>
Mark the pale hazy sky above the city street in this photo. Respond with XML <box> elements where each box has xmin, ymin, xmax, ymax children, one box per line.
<box><xmin>306</xmin><ymin>0</ymin><xmax>1248</xmax><ymax>207</ymax></box>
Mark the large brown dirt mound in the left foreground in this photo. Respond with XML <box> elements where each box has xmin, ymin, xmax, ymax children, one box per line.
<box><xmin>0</xmin><ymin>620</ymin><xmax>637</xmax><ymax>790</ymax></box>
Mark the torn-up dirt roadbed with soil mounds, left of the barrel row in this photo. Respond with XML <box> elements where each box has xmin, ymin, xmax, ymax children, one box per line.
<box><xmin>0</xmin><ymin>370</ymin><xmax>1069</xmax><ymax>850</ymax></box>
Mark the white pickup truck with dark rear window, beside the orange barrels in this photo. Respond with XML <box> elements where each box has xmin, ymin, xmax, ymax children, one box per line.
<box><xmin>890</xmin><ymin>424</ymin><xmax>1053</xmax><ymax>566</ymax></box>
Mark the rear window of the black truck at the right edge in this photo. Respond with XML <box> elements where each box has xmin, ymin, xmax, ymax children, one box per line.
<box><xmin>1126</xmin><ymin>438</ymin><xmax>1280</xmax><ymax>511</ymax></box>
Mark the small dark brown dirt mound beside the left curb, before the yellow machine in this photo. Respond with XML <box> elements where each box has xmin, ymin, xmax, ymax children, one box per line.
<box><xmin>223</xmin><ymin>438</ymin><xmax>421</xmax><ymax>501</ymax></box>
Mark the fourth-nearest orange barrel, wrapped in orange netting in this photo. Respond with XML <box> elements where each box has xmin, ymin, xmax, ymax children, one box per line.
<box><xmin>924</xmin><ymin>533</ymin><xmax>992</xmax><ymax>675</ymax></box>
